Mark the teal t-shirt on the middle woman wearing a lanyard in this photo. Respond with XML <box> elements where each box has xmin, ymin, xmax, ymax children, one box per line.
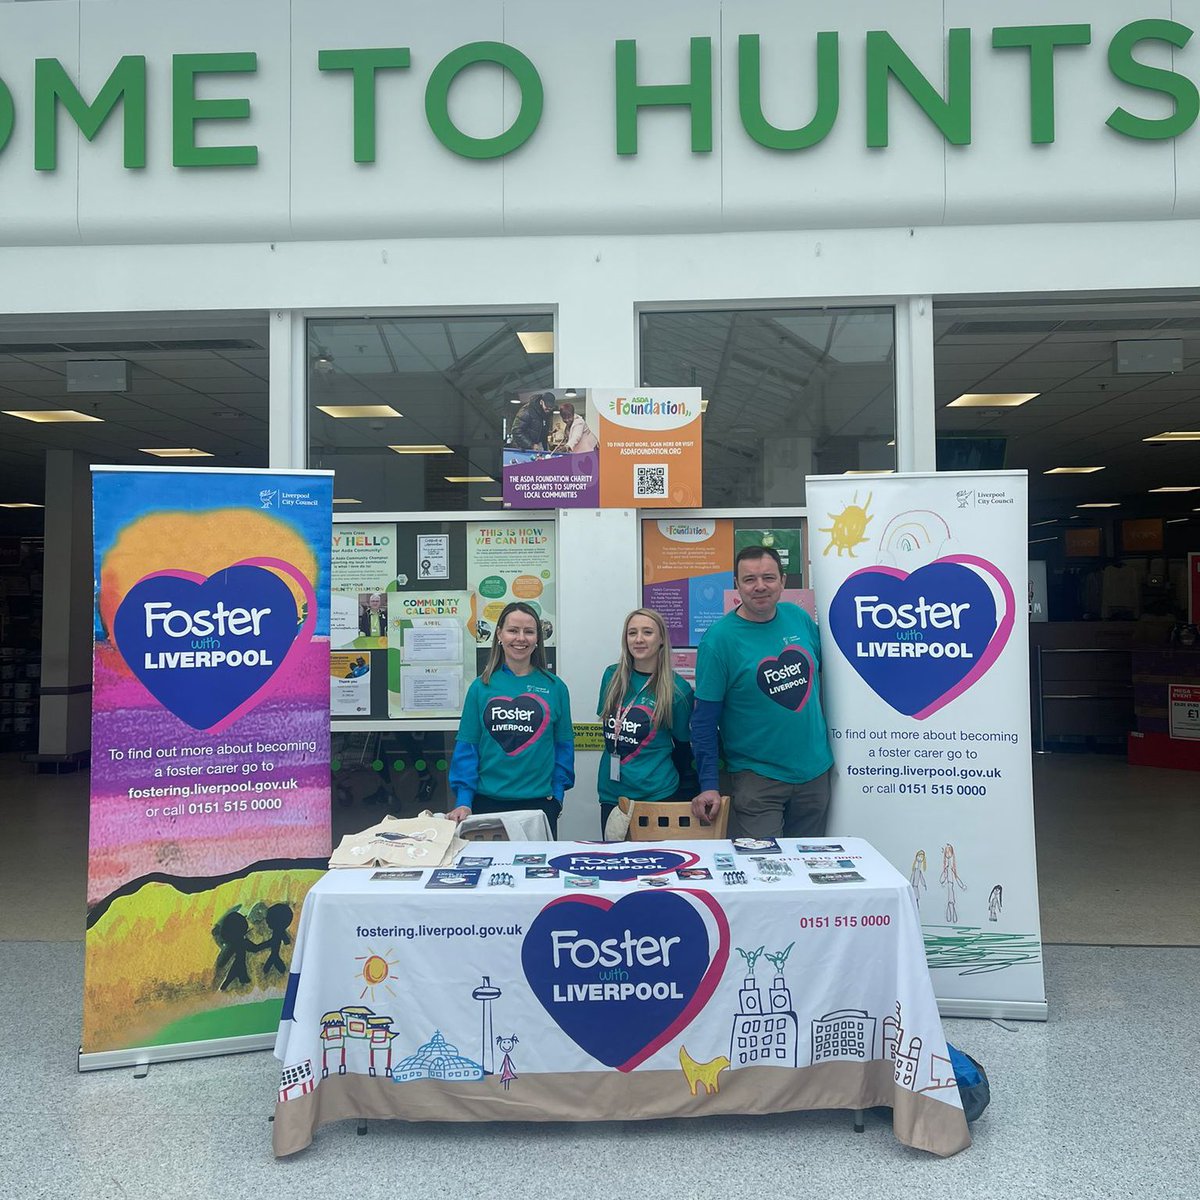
<box><xmin>596</xmin><ymin>665</ymin><xmax>692</xmax><ymax>804</ymax></box>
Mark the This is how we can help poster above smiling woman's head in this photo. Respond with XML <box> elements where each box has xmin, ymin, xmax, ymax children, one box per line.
<box><xmin>467</xmin><ymin>521</ymin><xmax>558</xmax><ymax>646</ymax></box>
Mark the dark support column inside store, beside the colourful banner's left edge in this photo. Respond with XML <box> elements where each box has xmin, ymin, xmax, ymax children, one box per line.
<box><xmin>37</xmin><ymin>450</ymin><xmax>94</xmax><ymax>755</ymax></box>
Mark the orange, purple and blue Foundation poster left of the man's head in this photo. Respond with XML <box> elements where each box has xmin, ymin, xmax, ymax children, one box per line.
<box><xmin>642</xmin><ymin>517</ymin><xmax>733</xmax><ymax>647</ymax></box>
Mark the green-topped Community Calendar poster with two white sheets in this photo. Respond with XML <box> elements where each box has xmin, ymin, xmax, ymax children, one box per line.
<box><xmin>388</xmin><ymin>592</ymin><xmax>475</xmax><ymax>716</ymax></box>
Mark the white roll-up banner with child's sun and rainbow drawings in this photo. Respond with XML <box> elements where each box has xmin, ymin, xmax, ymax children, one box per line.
<box><xmin>808</xmin><ymin>470</ymin><xmax>1046</xmax><ymax>1020</ymax></box>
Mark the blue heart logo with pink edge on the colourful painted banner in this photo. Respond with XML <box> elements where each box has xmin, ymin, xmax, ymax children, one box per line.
<box><xmin>113</xmin><ymin>563</ymin><xmax>304</xmax><ymax>732</ymax></box>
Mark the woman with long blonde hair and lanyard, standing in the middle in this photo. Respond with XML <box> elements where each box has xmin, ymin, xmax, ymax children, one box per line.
<box><xmin>596</xmin><ymin>608</ymin><xmax>692</xmax><ymax>833</ymax></box>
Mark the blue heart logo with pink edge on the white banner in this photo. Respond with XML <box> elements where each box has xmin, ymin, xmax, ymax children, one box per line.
<box><xmin>829</xmin><ymin>554</ymin><xmax>1015</xmax><ymax>720</ymax></box>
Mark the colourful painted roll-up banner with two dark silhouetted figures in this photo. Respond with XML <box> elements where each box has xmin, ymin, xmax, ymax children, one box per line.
<box><xmin>79</xmin><ymin>467</ymin><xmax>334</xmax><ymax>1070</ymax></box>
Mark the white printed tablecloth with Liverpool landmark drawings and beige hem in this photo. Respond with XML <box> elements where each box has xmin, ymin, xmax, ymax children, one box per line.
<box><xmin>274</xmin><ymin>839</ymin><xmax>970</xmax><ymax>1154</ymax></box>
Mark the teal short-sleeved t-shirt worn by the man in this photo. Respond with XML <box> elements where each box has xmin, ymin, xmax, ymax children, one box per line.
<box><xmin>696</xmin><ymin>601</ymin><xmax>833</xmax><ymax>784</ymax></box>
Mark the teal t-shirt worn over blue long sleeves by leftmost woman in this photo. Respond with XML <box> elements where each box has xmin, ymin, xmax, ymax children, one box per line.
<box><xmin>458</xmin><ymin>667</ymin><xmax>575</xmax><ymax>800</ymax></box>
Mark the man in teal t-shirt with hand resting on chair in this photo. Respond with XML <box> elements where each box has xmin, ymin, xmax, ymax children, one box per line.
<box><xmin>691</xmin><ymin>546</ymin><xmax>833</xmax><ymax>838</ymax></box>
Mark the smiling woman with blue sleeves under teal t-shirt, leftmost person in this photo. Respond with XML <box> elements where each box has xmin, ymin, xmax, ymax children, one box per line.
<box><xmin>450</xmin><ymin>601</ymin><xmax>575</xmax><ymax>838</ymax></box>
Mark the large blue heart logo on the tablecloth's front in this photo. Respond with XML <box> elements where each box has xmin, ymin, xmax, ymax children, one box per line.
<box><xmin>521</xmin><ymin>890</ymin><xmax>730</xmax><ymax>1070</ymax></box>
